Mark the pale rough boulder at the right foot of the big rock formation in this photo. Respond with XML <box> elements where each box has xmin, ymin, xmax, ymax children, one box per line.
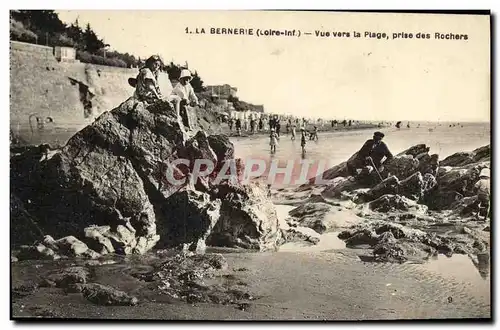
<box><xmin>206</xmin><ymin>183</ymin><xmax>281</xmax><ymax>251</ymax></box>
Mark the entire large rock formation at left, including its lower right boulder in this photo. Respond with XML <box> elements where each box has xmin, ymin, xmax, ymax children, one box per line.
<box><xmin>11</xmin><ymin>98</ymin><xmax>280</xmax><ymax>253</ymax></box>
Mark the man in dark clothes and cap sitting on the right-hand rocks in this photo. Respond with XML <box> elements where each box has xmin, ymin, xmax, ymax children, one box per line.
<box><xmin>347</xmin><ymin>132</ymin><xmax>394</xmax><ymax>176</ymax></box>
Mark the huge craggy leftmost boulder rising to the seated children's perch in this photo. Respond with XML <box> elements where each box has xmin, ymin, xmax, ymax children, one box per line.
<box><xmin>12</xmin><ymin>99</ymin><xmax>187</xmax><ymax>253</ymax></box>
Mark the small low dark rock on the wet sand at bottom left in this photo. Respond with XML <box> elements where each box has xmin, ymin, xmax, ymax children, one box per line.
<box><xmin>80</xmin><ymin>283</ymin><xmax>139</xmax><ymax>306</ymax></box>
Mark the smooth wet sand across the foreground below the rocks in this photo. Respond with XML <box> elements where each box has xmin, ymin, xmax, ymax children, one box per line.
<box><xmin>12</xmin><ymin>249</ymin><xmax>491</xmax><ymax>320</ymax></box>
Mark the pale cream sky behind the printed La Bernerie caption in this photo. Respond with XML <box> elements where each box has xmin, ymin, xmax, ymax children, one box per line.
<box><xmin>58</xmin><ymin>10</ymin><xmax>490</xmax><ymax>121</ymax></box>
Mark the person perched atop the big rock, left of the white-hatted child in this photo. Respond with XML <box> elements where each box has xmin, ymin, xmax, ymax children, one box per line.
<box><xmin>129</xmin><ymin>55</ymin><xmax>163</xmax><ymax>103</ymax></box>
